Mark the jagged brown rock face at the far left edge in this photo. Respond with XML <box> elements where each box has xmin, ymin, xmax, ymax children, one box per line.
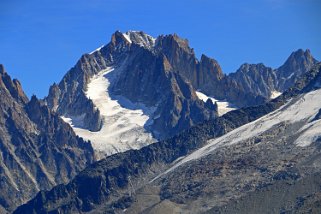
<box><xmin>0</xmin><ymin>65</ymin><xmax>94</xmax><ymax>211</ymax></box>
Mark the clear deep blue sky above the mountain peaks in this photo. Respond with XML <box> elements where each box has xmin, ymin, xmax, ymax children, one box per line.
<box><xmin>0</xmin><ymin>0</ymin><xmax>321</xmax><ymax>97</ymax></box>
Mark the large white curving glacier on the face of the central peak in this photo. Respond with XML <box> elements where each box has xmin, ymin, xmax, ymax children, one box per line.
<box><xmin>63</xmin><ymin>68</ymin><xmax>155</xmax><ymax>158</ymax></box>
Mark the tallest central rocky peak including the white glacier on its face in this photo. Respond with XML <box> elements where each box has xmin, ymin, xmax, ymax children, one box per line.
<box><xmin>46</xmin><ymin>31</ymin><xmax>217</xmax><ymax>155</ymax></box>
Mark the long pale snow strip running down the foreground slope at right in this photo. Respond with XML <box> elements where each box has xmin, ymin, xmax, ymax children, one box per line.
<box><xmin>154</xmin><ymin>89</ymin><xmax>321</xmax><ymax>180</ymax></box>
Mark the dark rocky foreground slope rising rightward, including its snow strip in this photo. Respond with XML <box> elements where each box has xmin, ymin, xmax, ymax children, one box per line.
<box><xmin>15</xmin><ymin>59</ymin><xmax>321</xmax><ymax>213</ymax></box>
